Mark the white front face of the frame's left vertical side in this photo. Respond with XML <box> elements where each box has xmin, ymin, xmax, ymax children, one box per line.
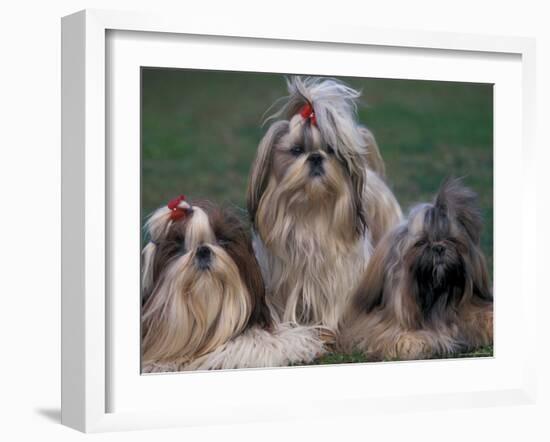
<box><xmin>84</xmin><ymin>10</ymin><xmax>108</xmax><ymax>432</ymax></box>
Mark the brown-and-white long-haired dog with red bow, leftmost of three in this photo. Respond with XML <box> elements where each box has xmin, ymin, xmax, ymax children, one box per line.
<box><xmin>142</xmin><ymin>197</ymin><xmax>323</xmax><ymax>372</ymax></box>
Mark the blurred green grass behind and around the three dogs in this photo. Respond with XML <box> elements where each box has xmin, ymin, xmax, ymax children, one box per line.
<box><xmin>141</xmin><ymin>68</ymin><xmax>493</xmax><ymax>362</ymax></box>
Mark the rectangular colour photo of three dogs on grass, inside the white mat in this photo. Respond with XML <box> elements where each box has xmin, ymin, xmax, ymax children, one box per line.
<box><xmin>140</xmin><ymin>67</ymin><xmax>493</xmax><ymax>373</ymax></box>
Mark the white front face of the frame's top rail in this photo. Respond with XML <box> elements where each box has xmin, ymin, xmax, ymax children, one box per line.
<box><xmin>91</xmin><ymin>9</ymin><xmax>532</xmax><ymax>53</ymax></box>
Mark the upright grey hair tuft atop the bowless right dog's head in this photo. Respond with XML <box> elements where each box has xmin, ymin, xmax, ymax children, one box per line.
<box><xmin>434</xmin><ymin>178</ymin><xmax>482</xmax><ymax>244</ymax></box>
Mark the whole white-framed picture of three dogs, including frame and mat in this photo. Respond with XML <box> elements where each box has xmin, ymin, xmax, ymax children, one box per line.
<box><xmin>62</xmin><ymin>11</ymin><xmax>536</xmax><ymax>432</ymax></box>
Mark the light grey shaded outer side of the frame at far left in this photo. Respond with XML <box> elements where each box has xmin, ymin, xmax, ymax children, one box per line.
<box><xmin>61</xmin><ymin>12</ymin><xmax>86</xmax><ymax>431</ymax></box>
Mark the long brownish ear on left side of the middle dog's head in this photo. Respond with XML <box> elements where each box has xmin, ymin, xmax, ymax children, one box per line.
<box><xmin>247</xmin><ymin>120</ymin><xmax>288</xmax><ymax>224</ymax></box>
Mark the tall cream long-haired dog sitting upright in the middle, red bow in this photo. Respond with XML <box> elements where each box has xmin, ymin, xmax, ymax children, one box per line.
<box><xmin>247</xmin><ymin>77</ymin><xmax>401</xmax><ymax>331</ymax></box>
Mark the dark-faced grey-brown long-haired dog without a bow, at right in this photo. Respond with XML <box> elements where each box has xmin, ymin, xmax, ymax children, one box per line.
<box><xmin>340</xmin><ymin>180</ymin><xmax>493</xmax><ymax>360</ymax></box>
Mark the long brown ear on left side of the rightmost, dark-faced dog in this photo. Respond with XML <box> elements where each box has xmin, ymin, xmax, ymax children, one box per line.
<box><xmin>353</xmin><ymin>231</ymin><xmax>396</xmax><ymax>313</ymax></box>
